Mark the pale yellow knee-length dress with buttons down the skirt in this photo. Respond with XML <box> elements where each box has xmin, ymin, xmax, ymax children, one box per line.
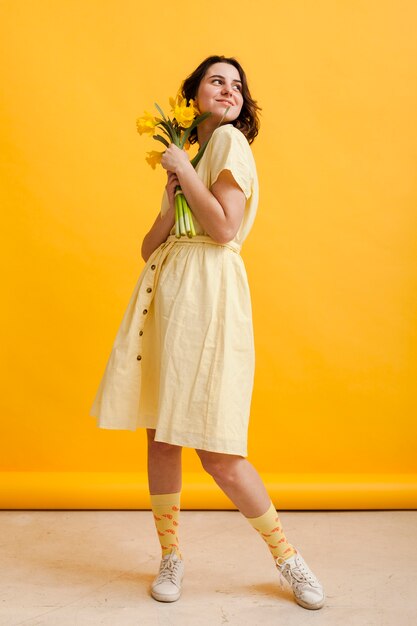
<box><xmin>90</xmin><ymin>124</ymin><xmax>258</xmax><ymax>457</ymax></box>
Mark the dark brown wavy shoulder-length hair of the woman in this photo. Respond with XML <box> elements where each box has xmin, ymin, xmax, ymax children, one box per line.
<box><xmin>181</xmin><ymin>55</ymin><xmax>262</xmax><ymax>143</ymax></box>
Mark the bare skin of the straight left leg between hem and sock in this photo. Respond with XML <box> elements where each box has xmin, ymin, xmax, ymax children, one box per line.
<box><xmin>146</xmin><ymin>428</ymin><xmax>182</xmax><ymax>495</ymax></box>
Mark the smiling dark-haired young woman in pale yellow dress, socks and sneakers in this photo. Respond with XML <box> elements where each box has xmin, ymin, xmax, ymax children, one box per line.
<box><xmin>91</xmin><ymin>56</ymin><xmax>325</xmax><ymax>609</ymax></box>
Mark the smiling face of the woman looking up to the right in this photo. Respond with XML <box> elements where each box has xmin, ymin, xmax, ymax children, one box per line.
<box><xmin>195</xmin><ymin>63</ymin><xmax>243</xmax><ymax>124</ymax></box>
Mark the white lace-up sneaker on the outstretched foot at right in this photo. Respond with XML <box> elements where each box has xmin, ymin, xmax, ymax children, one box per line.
<box><xmin>275</xmin><ymin>550</ymin><xmax>325</xmax><ymax>609</ymax></box>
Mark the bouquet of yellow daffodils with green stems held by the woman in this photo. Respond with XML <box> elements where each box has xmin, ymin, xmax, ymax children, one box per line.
<box><xmin>136</xmin><ymin>92</ymin><xmax>211</xmax><ymax>238</ymax></box>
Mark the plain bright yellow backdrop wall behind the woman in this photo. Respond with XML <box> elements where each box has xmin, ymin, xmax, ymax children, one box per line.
<box><xmin>0</xmin><ymin>0</ymin><xmax>417</xmax><ymax>509</ymax></box>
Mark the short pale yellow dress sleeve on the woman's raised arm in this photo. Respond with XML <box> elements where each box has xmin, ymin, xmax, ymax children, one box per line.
<box><xmin>209</xmin><ymin>124</ymin><xmax>254</xmax><ymax>198</ymax></box>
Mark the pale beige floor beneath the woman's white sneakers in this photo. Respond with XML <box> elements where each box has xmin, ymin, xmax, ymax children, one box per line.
<box><xmin>0</xmin><ymin>511</ymin><xmax>417</xmax><ymax>626</ymax></box>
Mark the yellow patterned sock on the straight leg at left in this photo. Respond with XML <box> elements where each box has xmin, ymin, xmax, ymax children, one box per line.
<box><xmin>150</xmin><ymin>491</ymin><xmax>182</xmax><ymax>559</ymax></box>
